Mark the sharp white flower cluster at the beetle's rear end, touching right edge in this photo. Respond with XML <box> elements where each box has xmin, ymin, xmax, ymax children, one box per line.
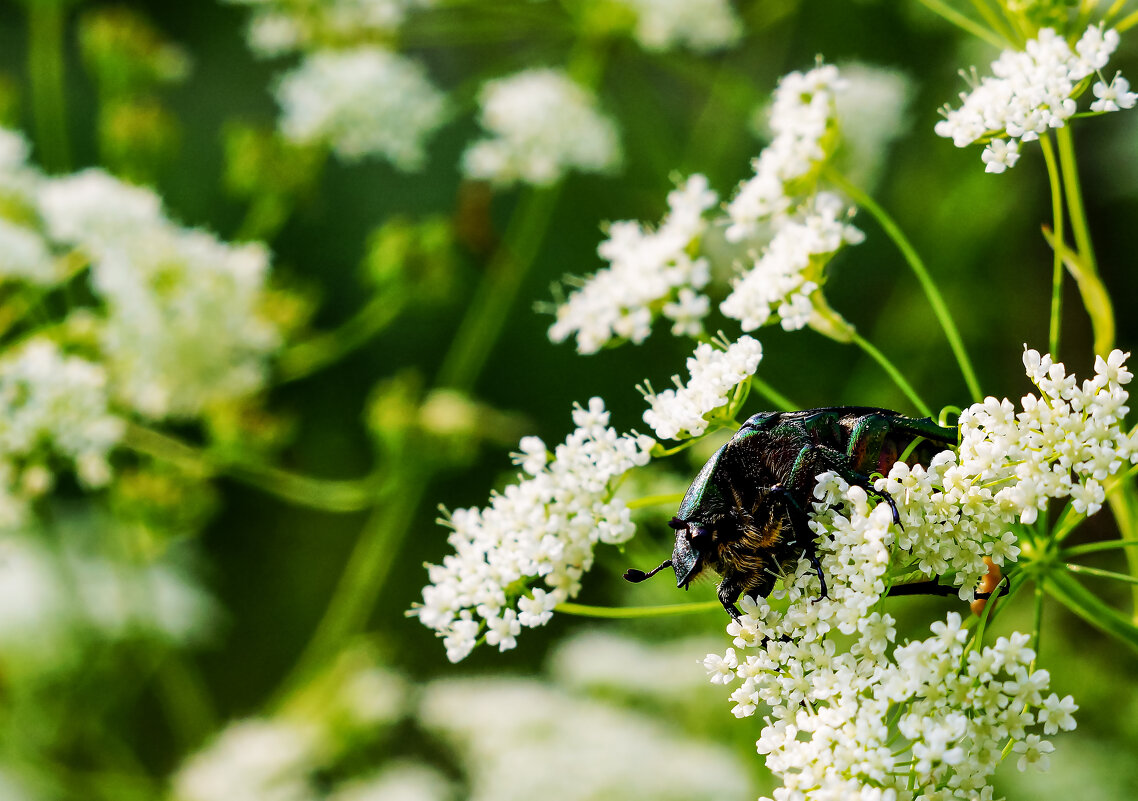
<box><xmin>876</xmin><ymin>343</ymin><xmax>1138</xmax><ymax>600</ymax></box>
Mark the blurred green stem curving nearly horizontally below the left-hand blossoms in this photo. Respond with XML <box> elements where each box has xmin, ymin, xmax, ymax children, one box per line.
<box><xmin>122</xmin><ymin>422</ymin><xmax>382</xmax><ymax>512</ymax></box>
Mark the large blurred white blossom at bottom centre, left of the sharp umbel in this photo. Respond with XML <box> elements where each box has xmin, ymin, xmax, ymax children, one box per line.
<box><xmin>420</xmin><ymin>679</ymin><xmax>753</xmax><ymax>801</ymax></box>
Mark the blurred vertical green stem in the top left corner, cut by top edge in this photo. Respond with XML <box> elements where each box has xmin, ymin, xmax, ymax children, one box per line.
<box><xmin>25</xmin><ymin>0</ymin><xmax>71</xmax><ymax>173</ymax></box>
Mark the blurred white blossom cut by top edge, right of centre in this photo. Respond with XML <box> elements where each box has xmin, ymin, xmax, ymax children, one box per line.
<box><xmin>620</xmin><ymin>0</ymin><xmax>743</xmax><ymax>52</ymax></box>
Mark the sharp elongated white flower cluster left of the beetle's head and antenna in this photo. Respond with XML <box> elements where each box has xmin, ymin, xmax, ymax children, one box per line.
<box><xmin>412</xmin><ymin>398</ymin><xmax>654</xmax><ymax>662</ymax></box>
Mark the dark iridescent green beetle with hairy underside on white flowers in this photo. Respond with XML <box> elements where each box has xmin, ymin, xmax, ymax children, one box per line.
<box><xmin>625</xmin><ymin>406</ymin><xmax>957</xmax><ymax>619</ymax></box>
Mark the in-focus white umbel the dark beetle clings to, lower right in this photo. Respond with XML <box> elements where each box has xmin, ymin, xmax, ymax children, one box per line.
<box><xmin>704</xmin><ymin>350</ymin><xmax>1138</xmax><ymax>801</ymax></box>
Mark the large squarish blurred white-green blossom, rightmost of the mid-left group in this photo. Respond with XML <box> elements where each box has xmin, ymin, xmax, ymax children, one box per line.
<box><xmin>91</xmin><ymin>228</ymin><xmax>280</xmax><ymax>419</ymax></box>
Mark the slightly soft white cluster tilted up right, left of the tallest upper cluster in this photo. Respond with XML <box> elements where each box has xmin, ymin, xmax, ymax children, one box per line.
<box><xmin>550</xmin><ymin>175</ymin><xmax>718</xmax><ymax>354</ymax></box>
